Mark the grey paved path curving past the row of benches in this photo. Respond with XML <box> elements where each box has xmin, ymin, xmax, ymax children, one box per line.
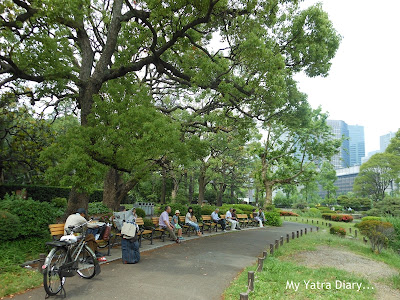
<box><xmin>14</xmin><ymin>222</ymin><xmax>311</xmax><ymax>300</ymax></box>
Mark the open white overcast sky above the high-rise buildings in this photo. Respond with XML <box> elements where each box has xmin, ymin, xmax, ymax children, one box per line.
<box><xmin>295</xmin><ymin>0</ymin><xmax>400</xmax><ymax>154</ymax></box>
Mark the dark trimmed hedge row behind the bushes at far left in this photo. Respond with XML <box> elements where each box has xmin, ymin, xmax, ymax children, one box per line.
<box><xmin>0</xmin><ymin>184</ymin><xmax>103</xmax><ymax>202</ymax></box>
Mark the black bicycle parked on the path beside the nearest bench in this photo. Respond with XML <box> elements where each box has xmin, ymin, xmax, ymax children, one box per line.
<box><xmin>42</xmin><ymin>222</ymin><xmax>101</xmax><ymax>298</ymax></box>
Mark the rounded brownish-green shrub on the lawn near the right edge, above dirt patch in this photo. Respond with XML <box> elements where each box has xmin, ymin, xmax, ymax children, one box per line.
<box><xmin>357</xmin><ymin>220</ymin><xmax>394</xmax><ymax>253</ymax></box>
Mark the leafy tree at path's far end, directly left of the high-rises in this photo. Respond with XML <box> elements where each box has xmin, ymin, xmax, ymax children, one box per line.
<box><xmin>254</xmin><ymin>103</ymin><xmax>340</xmax><ymax>205</ymax></box>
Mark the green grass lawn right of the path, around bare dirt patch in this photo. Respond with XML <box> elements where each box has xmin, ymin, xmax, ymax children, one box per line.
<box><xmin>224</xmin><ymin>225</ymin><xmax>400</xmax><ymax>300</ymax></box>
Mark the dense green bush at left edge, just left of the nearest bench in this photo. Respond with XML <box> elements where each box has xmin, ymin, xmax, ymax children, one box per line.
<box><xmin>0</xmin><ymin>194</ymin><xmax>61</xmax><ymax>237</ymax></box>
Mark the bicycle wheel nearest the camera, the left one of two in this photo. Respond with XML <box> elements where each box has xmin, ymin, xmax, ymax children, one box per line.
<box><xmin>43</xmin><ymin>247</ymin><xmax>67</xmax><ymax>296</ymax></box>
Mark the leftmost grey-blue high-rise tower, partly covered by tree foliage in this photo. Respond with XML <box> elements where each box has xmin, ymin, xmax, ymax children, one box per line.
<box><xmin>327</xmin><ymin>120</ymin><xmax>350</xmax><ymax>169</ymax></box>
